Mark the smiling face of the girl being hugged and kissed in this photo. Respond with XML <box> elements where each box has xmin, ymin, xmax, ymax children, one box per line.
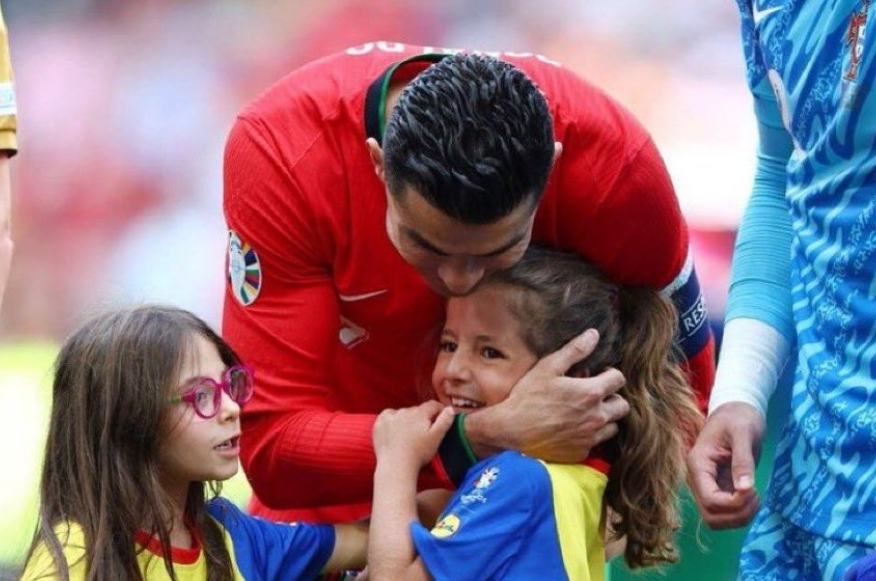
<box><xmin>432</xmin><ymin>285</ymin><xmax>537</xmax><ymax>413</ymax></box>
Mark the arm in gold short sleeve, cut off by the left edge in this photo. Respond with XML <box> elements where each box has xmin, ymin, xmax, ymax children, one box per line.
<box><xmin>0</xmin><ymin>1</ymin><xmax>18</xmax><ymax>318</ymax></box>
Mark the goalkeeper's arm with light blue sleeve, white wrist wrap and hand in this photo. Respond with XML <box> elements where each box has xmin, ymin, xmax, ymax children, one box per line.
<box><xmin>688</xmin><ymin>67</ymin><xmax>794</xmax><ymax>528</ymax></box>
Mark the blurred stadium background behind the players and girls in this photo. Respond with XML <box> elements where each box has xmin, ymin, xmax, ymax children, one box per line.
<box><xmin>0</xmin><ymin>0</ymin><xmax>766</xmax><ymax>581</ymax></box>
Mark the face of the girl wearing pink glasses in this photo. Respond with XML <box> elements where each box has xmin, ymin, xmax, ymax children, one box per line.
<box><xmin>158</xmin><ymin>335</ymin><xmax>240</xmax><ymax>490</ymax></box>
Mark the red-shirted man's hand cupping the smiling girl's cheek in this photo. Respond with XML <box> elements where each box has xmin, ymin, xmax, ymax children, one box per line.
<box><xmin>465</xmin><ymin>329</ymin><xmax>630</xmax><ymax>462</ymax></box>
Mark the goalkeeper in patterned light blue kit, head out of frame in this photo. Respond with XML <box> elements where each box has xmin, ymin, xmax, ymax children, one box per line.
<box><xmin>689</xmin><ymin>0</ymin><xmax>876</xmax><ymax>581</ymax></box>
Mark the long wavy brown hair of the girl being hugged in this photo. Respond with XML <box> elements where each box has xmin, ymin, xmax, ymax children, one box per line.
<box><xmin>482</xmin><ymin>247</ymin><xmax>702</xmax><ymax>568</ymax></box>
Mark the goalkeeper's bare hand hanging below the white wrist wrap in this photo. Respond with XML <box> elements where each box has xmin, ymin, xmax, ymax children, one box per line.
<box><xmin>687</xmin><ymin>402</ymin><xmax>765</xmax><ymax>529</ymax></box>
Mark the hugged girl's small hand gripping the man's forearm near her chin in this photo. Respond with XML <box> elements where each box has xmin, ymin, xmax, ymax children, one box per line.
<box><xmin>373</xmin><ymin>400</ymin><xmax>453</xmax><ymax>471</ymax></box>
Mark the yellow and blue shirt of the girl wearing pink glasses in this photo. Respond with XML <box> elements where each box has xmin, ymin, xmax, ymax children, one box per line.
<box><xmin>21</xmin><ymin>498</ymin><xmax>335</xmax><ymax>581</ymax></box>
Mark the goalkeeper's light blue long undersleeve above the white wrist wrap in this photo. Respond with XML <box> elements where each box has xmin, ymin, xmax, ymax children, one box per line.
<box><xmin>726</xmin><ymin>24</ymin><xmax>795</xmax><ymax>342</ymax></box>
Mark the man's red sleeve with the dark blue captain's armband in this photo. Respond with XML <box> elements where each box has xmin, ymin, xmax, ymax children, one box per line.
<box><xmin>537</xmin><ymin>122</ymin><xmax>715</xmax><ymax>410</ymax></box>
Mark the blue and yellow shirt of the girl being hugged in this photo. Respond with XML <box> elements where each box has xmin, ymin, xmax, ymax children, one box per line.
<box><xmin>411</xmin><ymin>451</ymin><xmax>607</xmax><ymax>581</ymax></box>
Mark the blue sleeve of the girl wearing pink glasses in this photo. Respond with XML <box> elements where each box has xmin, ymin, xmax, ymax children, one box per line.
<box><xmin>207</xmin><ymin>498</ymin><xmax>335</xmax><ymax>581</ymax></box>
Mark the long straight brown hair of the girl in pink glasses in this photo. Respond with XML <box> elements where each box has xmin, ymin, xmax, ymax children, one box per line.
<box><xmin>29</xmin><ymin>306</ymin><xmax>239</xmax><ymax>581</ymax></box>
